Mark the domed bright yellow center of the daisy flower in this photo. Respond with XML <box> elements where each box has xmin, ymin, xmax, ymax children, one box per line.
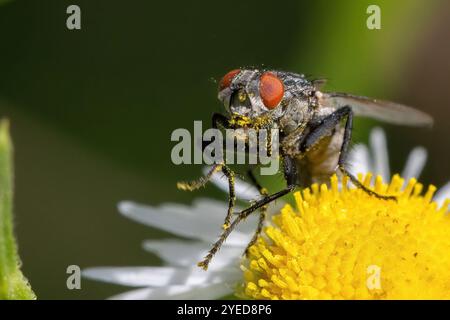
<box><xmin>240</xmin><ymin>174</ymin><xmax>450</xmax><ymax>299</ymax></box>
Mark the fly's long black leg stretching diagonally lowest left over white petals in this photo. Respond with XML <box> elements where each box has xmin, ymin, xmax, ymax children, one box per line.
<box><xmin>197</xmin><ymin>157</ymin><xmax>297</xmax><ymax>270</ymax></box>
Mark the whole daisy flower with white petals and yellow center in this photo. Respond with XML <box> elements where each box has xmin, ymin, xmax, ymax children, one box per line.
<box><xmin>83</xmin><ymin>129</ymin><xmax>450</xmax><ymax>299</ymax></box>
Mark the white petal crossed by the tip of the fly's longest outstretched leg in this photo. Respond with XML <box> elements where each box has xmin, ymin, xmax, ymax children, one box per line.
<box><xmin>143</xmin><ymin>240</ymin><xmax>246</xmax><ymax>271</ymax></box>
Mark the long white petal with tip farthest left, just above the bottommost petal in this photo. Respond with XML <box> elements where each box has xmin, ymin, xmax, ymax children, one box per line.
<box><xmin>82</xmin><ymin>267</ymin><xmax>239</xmax><ymax>287</ymax></box>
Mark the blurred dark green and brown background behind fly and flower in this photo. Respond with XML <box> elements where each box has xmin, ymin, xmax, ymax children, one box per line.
<box><xmin>0</xmin><ymin>0</ymin><xmax>450</xmax><ymax>299</ymax></box>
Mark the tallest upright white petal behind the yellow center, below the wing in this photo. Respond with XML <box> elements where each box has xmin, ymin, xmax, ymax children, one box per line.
<box><xmin>370</xmin><ymin>128</ymin><xmax>391</xmax><ymax>181</ymax></box>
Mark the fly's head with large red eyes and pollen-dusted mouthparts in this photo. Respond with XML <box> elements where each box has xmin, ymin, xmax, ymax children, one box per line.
<box><xmin>218</xmin><ymin>69</ymin><xmax>314</xmax><ymax>135</ymax></box>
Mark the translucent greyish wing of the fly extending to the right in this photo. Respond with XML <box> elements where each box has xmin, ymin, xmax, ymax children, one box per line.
<box><xmin>319</xmin><ymin>93</ymin><xmax>433</xmax><ymax>126</ymax></box>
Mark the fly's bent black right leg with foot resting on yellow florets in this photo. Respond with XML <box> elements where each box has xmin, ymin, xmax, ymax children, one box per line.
<box><xmin>300</xmin><ymin>106</ymin><xmax>397</xmax><ymax>200</ymax></box>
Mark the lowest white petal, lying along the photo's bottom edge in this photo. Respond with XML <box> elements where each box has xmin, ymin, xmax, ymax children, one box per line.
<box><xmin>110</xmin><ymin>283</ymin><xmax>233</xmax><ymax>300</ymax></box>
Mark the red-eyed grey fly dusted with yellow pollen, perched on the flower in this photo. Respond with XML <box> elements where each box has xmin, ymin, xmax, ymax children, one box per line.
<box><xmin>178</xmin><ymin>69</ymin><xmax>433</xmax><ymax>270</ymax></box>
